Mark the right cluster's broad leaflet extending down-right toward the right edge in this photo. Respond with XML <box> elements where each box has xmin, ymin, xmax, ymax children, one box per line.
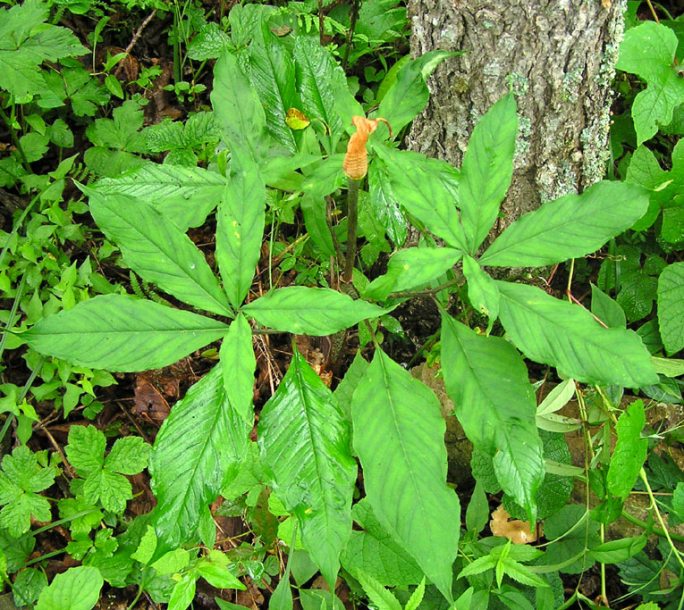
<box><xmin>497</xmin><ymin>281</ymin><xmax>658</xmax><ymax>387</ymax></box>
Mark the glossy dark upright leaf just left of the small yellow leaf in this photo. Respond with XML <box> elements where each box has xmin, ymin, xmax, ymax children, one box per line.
<box><xmin>248</xmin><ymin>31</ymin><xmax>300</xmax><ymax>153</ymax></box>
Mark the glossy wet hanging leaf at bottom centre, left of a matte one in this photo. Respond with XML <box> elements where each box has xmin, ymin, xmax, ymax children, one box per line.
<box><xmin>259</xmin><ymin>350</ymin><xmax>356</xmax><ymax>585</ymax></box>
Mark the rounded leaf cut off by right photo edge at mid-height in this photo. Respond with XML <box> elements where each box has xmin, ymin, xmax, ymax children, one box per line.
<box><xmin>658</xmin><ymin>263</ymin><xmax>684</xmax><ymax>354</ymax></box>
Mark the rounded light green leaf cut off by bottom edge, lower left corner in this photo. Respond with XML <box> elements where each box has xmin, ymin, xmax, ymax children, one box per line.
<box><xmin>36</xmin><ymin>566</ymin><xmax>104</xmax><ymax>610</ymax></box>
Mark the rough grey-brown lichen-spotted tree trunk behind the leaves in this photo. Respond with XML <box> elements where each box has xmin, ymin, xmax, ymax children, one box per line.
<box><xmin>408</xmin><ymin>0</ymin><xmax>625</xmax><ymax>231</ymax></box>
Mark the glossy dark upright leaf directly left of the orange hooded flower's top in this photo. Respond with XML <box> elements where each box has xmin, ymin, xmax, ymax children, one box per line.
<box><xmin>293</xmin><ymin>36</ymin><xmax>347</xmax><ymax>144</ymax></box>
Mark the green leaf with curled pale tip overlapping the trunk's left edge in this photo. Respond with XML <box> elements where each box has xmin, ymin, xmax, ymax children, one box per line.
<box><xmin>377</xmin><ymin>50</ymin><xmax>456</xmax><ymax>135</ymax></box>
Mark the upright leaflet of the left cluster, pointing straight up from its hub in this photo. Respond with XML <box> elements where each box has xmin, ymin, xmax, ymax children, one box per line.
<box><xmin>216</xmin><ymin>150</ymin><xmax>266</xmax><ymax>309</ymax></box>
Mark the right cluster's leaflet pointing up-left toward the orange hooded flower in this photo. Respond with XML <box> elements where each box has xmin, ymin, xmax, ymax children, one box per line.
<box><xmin>373</xmin><ymin>145</ymin><xmax>466</xmax><ymax>251</ymax></box>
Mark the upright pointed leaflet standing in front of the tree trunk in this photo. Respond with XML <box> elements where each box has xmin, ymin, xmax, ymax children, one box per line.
<box><xmin>459</xmin><ymin>94</ymin><xmax>518</xmax><ymax>254</ymax></box>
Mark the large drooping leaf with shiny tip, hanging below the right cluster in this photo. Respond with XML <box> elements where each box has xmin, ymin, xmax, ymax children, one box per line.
<box><xmin>442</xmin><ymin>315</ymin><xmax>544</xmax><ymax>522</ymax></box>
